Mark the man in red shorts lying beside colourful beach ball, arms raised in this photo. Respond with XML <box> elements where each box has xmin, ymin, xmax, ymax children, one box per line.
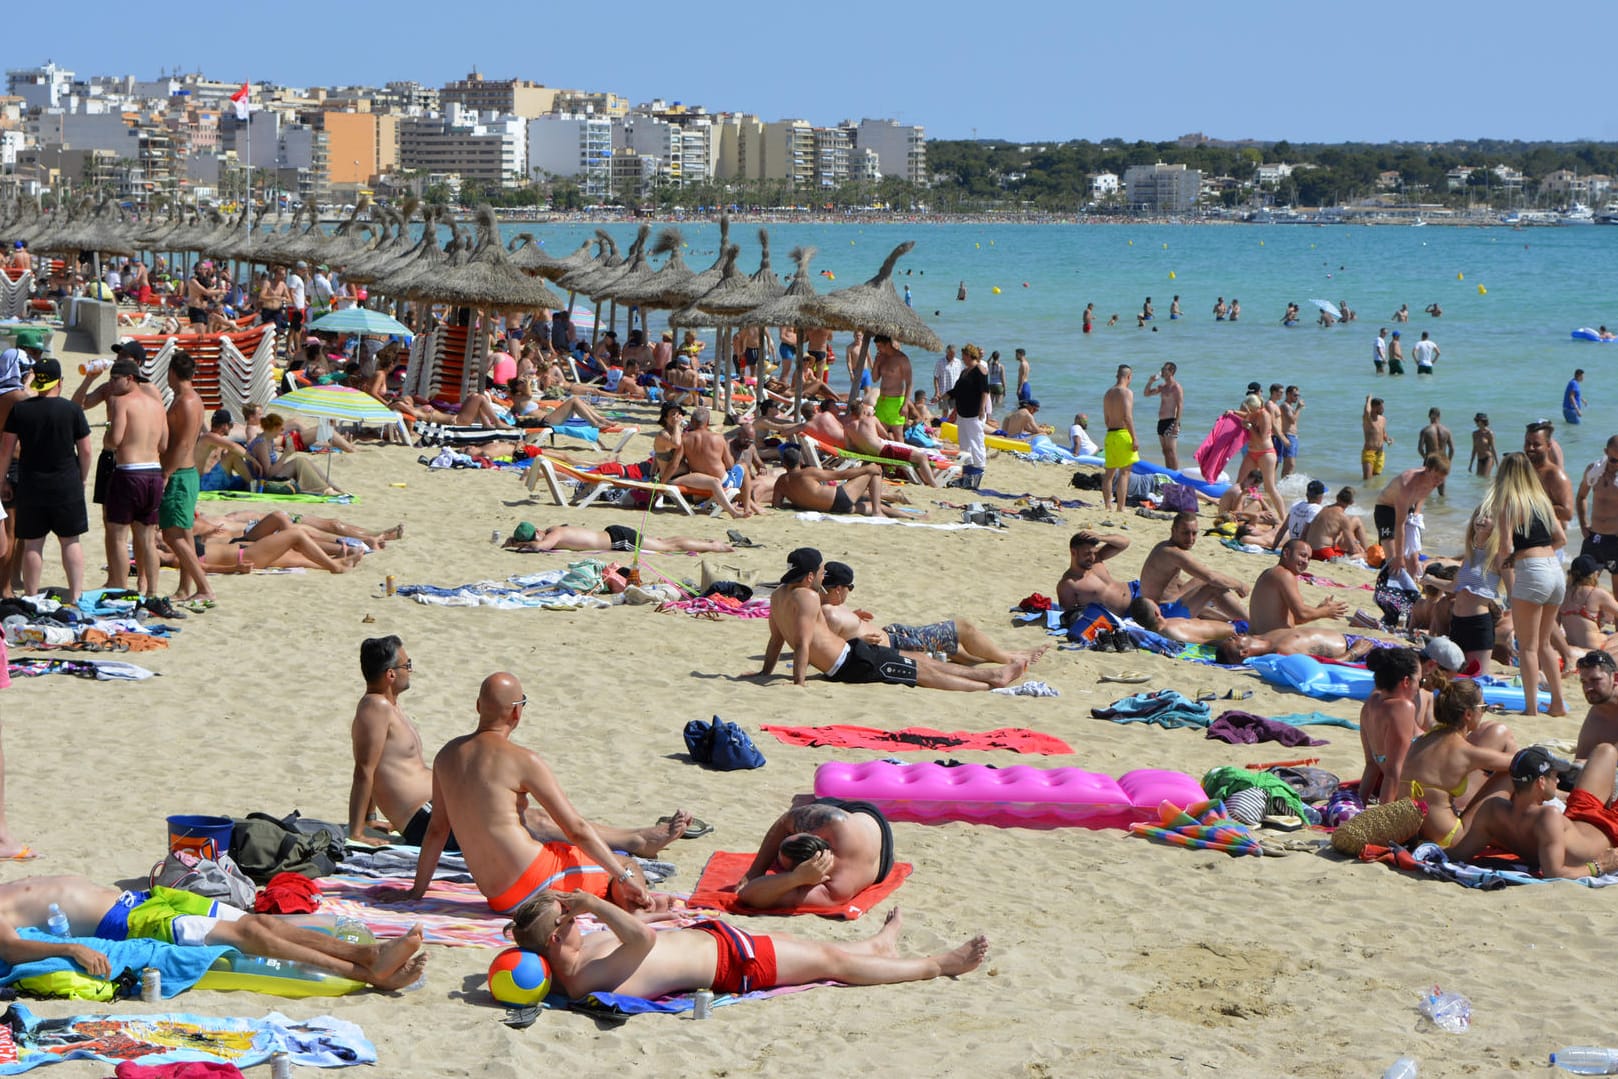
<box><xmin>511</xmin><ymin>891</ymin><xmax>989</xmax><ymax>998</ymax></box>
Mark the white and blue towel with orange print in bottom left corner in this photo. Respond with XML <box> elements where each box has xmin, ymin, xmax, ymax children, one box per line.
<box><xmin>0</xmin><ymin>1005</ymin><xmax>377</xmax><ymax>1076</ymax></box>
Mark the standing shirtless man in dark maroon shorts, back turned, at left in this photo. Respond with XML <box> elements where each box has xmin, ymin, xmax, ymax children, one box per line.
<box><xmin>104</xmin><ymin>358</ymin><xmax>169</xmax><ymax>613</ymax></box>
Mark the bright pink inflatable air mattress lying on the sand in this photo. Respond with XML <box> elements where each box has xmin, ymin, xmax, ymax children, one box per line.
<box><xmin>814</xmin><ymin>760</ymin><xmax>1207</xmax><ymax>828</ymax></box>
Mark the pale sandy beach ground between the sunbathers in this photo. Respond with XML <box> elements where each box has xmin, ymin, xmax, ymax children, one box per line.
<box><xmin>9</xmin><ymin>373</ymin><xmax>1618</xmax><ymax>1079</ymax></box>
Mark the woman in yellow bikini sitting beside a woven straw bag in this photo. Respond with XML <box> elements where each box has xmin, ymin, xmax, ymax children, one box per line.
<box><xmin>1398</xmin><ymin>678</ymin><xmax>1516</xmax><ymax>849</ymax></box>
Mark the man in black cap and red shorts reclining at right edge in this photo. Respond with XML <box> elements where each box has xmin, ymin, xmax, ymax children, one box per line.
<box><xmin>1450</xmin><ymin>744</ymin><xmax>1618</xmax><ymax>878</ymax></box>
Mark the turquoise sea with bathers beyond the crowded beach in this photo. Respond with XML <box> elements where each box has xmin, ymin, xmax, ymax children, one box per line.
<box><xmin>488</xmin><ymin>222</ymin><xmax>1618</xmax><ymax>550</ymax></box>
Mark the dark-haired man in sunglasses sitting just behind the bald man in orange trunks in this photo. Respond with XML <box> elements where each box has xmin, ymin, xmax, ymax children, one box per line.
<box><xmin>348</xmin><ymin>636</ymin><xmax>691</xmax><ymax>857</ymax></box>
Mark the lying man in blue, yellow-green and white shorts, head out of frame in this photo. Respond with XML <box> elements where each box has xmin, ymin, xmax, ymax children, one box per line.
<box><xmin>0</xmin><ymin>877</ymin><xmax>427</xmax><ymax>990</ymax></box>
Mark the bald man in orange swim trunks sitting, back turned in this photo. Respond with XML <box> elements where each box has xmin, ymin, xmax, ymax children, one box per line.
<box><xmin>385</xmin><ymin>671</ymin><xmax>652</xmax><ymax>914</ymax></box>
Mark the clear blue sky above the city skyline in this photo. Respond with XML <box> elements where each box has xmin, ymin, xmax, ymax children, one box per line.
<box><xmin>6</xmin><ymin>0</ymin><xmax>1618</xmax><ymax>142</ymax></box>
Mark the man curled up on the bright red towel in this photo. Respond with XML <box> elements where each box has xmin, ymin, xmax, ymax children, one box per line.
<box><xmin>736</xmin><ymin>798</ymin><xmax>893</xmax><ymax>911</ymax></box>
